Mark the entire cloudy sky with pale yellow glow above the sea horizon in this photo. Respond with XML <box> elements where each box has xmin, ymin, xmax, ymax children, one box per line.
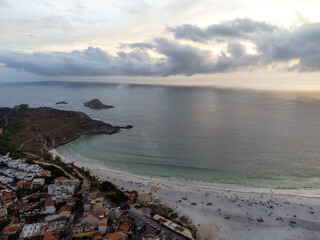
<box><xmin>0</xmin><ymin>0</ymin><xmax>320</xmax><ymax>90</ymax></box>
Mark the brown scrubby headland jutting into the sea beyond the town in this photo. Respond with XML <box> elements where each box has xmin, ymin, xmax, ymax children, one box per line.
<box><xmin>0</xmin><ymin>105</ymin><xmax>127</xmax><ymax>156</ymax></box>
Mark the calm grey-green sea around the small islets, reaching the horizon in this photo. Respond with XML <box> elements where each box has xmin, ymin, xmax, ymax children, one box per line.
<box><xmin>0</xmin><ymin>82</ymin><xmax>320</xmax><ymax>189</ymax></box>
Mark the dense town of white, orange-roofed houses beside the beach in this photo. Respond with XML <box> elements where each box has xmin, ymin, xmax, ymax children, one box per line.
<box><xmin>0</xmin><ymin>155</ymin><xmax>193</xmax><ymax>240</ymax></box>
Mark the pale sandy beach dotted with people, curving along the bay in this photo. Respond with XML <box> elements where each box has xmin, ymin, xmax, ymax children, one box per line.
<box><xmin>51</xmin><ymin>149</ymin><xmax>320</xmax><ymax>240</ymax></box>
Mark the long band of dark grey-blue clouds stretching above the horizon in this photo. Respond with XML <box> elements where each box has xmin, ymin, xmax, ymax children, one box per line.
<box><xmin>0</xmin><ymin>19</ymin><xmax>320</xmax><ymax>76</ymax></box>
